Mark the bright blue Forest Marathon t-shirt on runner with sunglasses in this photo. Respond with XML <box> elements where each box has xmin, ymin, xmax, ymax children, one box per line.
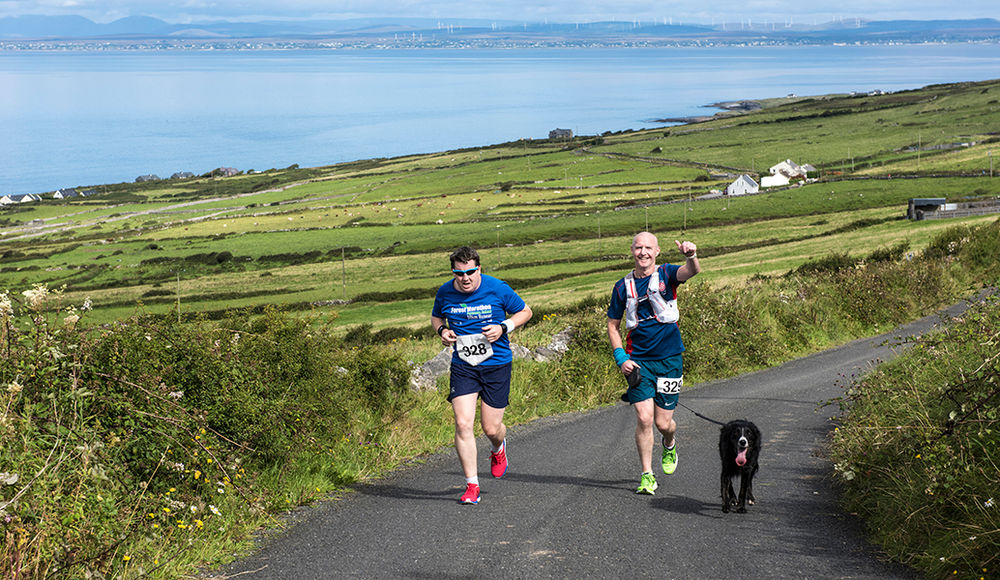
<box><xmin>431</xmin><ymin>274</ymin><xmax>527</xmax><ymax>366</ymax></box>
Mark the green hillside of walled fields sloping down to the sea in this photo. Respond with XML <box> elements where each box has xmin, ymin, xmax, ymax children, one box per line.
<box><xmin>0</xmin><ymin>81</ymin><xmax>1000</xmax><ymax>327</ymax></box>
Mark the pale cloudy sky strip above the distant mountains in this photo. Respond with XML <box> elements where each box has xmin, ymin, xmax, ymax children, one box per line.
<box><xmin>0</xmin><ymin>0</ymin><xmax>1000</xmax><ymax>25</ymax></box>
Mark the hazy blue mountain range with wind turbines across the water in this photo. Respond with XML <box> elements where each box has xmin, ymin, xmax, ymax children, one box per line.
<box><xmin>0</xmin><ymin>16</ymin><xmax>1000</xmax><ymax>46</ymax></box>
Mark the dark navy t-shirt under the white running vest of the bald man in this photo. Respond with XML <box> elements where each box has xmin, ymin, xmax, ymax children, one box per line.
<box><xmin>608</xmin><ymin>264</ymin><xmax>684</xmax><ymax>360</ymax></box>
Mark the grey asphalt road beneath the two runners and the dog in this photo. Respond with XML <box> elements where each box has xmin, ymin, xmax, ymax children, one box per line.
<box><xmin>217</xmin><ymin>305</ymin><xmax>976</xmax><ymax>580</ymax></box>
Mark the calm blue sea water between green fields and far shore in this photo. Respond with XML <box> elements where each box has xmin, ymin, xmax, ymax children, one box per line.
<box><xmin>0</xmin><ymin>44</ymin><xmax>1000</xmax><ymax>195</ymax></box>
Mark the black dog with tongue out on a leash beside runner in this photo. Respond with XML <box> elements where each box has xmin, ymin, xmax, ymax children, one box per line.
<box><xmin>719</xmin><ymin>419</ymin><xmax>760</xmax><ymax>514</ymax></box>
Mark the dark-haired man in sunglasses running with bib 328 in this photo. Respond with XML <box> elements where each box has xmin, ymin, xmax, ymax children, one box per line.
<box><xmin>431</xmin><ymin>246</ymin><xmax>531</xmax><ymax>504</ymax></box>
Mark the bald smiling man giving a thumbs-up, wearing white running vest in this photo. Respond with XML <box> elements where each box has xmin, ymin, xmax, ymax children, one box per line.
<box><xmin>608</xmin><ymin>232</ymin><xmax>701</xmax><ymax>495</ymax></box>
